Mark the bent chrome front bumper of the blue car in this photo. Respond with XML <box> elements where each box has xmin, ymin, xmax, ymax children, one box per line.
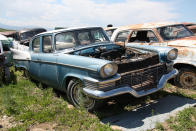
<box><xmin>83</xmin><ymin>69</ymin><xmax>178</xmax><ymax>99</ymax></box>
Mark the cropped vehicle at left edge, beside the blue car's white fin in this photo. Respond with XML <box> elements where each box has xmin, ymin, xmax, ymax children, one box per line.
<box><xmin>0</xmin><ymin>35</ymin><xmax>12</xmax><ymax>85</ymax></box>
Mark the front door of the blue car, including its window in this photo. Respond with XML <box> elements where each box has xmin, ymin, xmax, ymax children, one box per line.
<box><xmin>39</xmin><ymin>35</ymin><xmax>58</xmax><ymax>87</ymax></box>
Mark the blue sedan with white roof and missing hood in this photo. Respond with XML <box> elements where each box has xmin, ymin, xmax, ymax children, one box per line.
<box><xmin>12</xmin><ymin>27</ymin><xmax>177</xmax><ymax>110</ymax></box>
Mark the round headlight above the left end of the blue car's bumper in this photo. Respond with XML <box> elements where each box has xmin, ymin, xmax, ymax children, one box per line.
<box><xmin>100</xmin><ymin>63</ymin><xmax>118</xmax><ymax>78</ymax></box>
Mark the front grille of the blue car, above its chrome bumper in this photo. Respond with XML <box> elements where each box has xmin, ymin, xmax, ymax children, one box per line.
<box><xmin>85</xmin><ymin>63</ymin><xmax>167</xmax><ymax>91</ymax></box>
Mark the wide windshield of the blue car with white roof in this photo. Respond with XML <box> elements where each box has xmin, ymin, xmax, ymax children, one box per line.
<box><xmin>55</xmin><ymin>28</ymin><xmax>109</xmax><ymax>50</ymax></box>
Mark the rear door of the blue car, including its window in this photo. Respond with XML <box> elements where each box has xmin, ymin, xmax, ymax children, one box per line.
<box><xmin>29</xmin><ymin>37</ymin><xmax>41</xmax><ymax>80</ymax></box>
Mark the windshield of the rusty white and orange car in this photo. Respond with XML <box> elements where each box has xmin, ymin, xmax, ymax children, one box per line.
<box><xmin>157</xmin><ymin>25</ymin><xmax>193</xmax><ymax>41</ymax></box>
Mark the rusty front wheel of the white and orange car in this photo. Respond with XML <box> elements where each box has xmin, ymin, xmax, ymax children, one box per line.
<box><xmin>175</xmin><ymin>68</ymin><xmax>196</xmax><ymax>90</ymax></box>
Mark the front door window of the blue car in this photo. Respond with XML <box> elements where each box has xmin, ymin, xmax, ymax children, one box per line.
<box><xmin>42</xmin><ymin>36</ymin><xmax>53</xmax><ymax>53</ymax></box>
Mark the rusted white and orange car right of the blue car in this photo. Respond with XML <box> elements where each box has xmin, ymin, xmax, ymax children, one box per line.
<box><xmin>111</xmin><ymin>23</ymin><xmax>196</xmax><ymax>89</ymax></box>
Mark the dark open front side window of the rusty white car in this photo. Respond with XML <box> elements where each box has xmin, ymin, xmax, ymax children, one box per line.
<box><xmin>129</xmin><ymin>30</ymin><xmax>158</xmax><ymax>43</ymax></box>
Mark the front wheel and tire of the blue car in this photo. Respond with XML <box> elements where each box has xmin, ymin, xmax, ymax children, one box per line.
<box><xmin>67</xmin><ymin>79</ymin><xmax>103</xmax><ymax>111</ymax></box>
